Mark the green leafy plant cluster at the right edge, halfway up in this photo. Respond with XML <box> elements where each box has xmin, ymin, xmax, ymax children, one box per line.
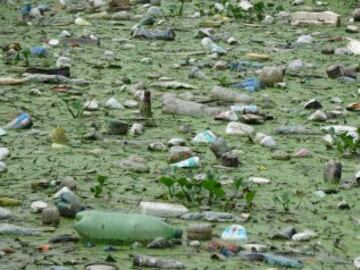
<box><xmin>330</xmin><ymin>127</ymin><xmax>360</xmax><ymax>156</ymax></box>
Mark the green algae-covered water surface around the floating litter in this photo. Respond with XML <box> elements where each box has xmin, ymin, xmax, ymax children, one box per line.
<box><xmin>0</xmin><ymin>0</ymin><xmax>360</xmax><ymax>270</ymax></box>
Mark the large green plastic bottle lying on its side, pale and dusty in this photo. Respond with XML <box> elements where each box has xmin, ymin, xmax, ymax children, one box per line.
<box><xmin>74</xmin><ymin>210</ymin><xmax>182</xmax><ymax>242</ymax></box>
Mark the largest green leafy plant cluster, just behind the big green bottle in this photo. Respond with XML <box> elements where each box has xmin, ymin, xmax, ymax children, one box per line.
<box><xmin>159</xmin><ymin>172</ymin><xmax>256</xmax><ymax>210</ymax></box>
